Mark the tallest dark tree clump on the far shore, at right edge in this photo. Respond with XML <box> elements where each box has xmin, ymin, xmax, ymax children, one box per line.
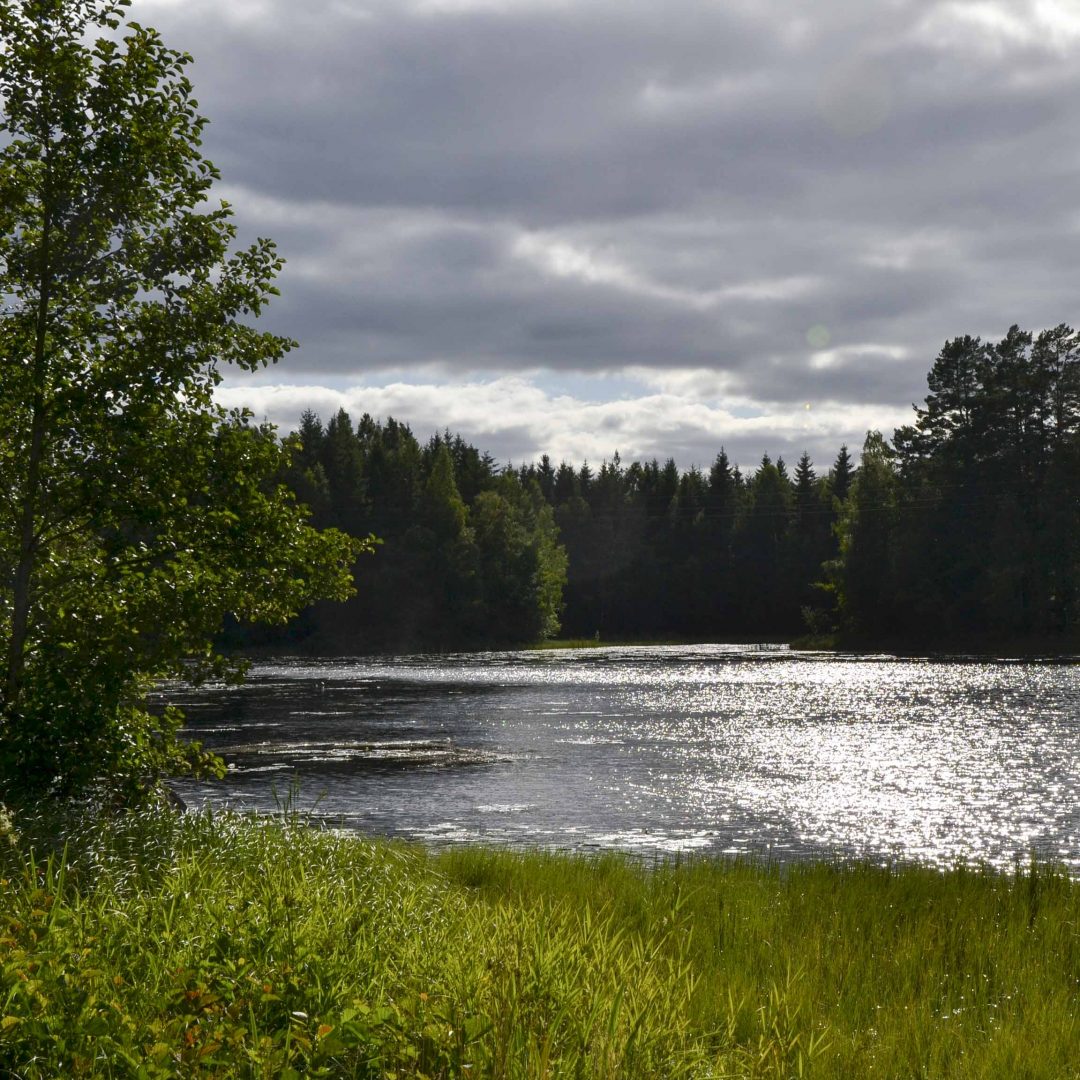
<box><xmin>828</xmin><ymin>325</ymin><xmax>1080</xmax><ymax>644</ymax></box>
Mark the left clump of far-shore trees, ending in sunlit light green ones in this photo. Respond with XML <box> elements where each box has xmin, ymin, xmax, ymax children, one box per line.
<box><xmin>251</xmin><ymin>410</ymin><xmax>566</xmax><ymax>652</ymax></box>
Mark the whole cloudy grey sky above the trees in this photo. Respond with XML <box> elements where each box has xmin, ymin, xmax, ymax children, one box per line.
<box><xmin>131</xmin><ymin>0</ymin><xmax>1080</xmax><ymax>471</ymax></box>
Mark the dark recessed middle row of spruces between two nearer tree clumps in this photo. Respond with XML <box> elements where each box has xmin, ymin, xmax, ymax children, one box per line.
<box><xmin>519</xmin><ymin>448</ymin><xmax>852</xmax><ymax>638</ymax></box>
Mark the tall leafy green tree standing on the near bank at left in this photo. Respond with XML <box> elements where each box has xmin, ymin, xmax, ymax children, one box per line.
<box><xmin>0</xmin><ymin>0</ymin><xmax>359</xmax><ymax>800</ymax></box>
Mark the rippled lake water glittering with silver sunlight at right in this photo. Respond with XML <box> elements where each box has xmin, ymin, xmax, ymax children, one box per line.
<box><xmin>165</xmin><ymin>646</ymin><xmax>1080</xmax><ymax>872</ymax></box>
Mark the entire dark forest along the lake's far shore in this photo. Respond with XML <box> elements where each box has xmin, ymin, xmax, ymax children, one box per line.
<box><xmin>236</xmin><ymin>325</ymin><xmax>1080</xmax><ymax>652</ymax></box>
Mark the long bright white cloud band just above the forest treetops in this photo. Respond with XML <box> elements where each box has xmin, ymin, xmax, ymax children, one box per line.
<box><xmin>217</xmin><ymin>372</ymin><xmax>910</xmax><ymax>468</ymax></box>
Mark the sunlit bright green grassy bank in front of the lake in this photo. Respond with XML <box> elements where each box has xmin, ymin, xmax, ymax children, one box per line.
<box><xmin>0</xmin><ymin>815</ymin><xmax>1080</xmax><ymax>1080</ymax></box>
